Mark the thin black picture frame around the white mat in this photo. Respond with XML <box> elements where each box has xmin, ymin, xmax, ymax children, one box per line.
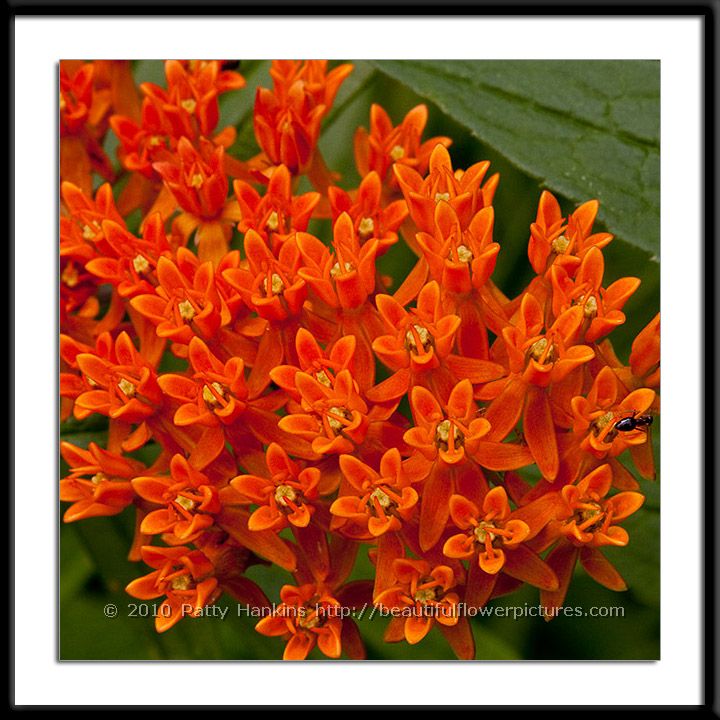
<box><xmin>11</xmin><ymin>0</ymin><xmax>720</xmax><ymax>717</ymax></box>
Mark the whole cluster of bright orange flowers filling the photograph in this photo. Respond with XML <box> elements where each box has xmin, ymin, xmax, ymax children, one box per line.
<box><xmin>60</xmin><ymin>61</ymin><xmax>659</xmax><ymax>659</ymax></box>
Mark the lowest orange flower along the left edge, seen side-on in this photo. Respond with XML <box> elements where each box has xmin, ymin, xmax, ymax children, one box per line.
<box><xmin>60</xmin><ymin>442</ymin><xmax>144</xmax><ymax>522</ymax></box>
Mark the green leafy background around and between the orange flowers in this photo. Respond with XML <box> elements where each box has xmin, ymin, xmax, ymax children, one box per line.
<box><xmin>59</xmin><ymin>61</ymin><xmax>660</xmax><ymax>660</ymax></box>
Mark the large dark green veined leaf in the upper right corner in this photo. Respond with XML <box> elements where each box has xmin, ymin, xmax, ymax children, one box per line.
<box><xmin>375</xmin><ymin>60</ymin><xmax>660</xmax><ymax>256</ymax></box>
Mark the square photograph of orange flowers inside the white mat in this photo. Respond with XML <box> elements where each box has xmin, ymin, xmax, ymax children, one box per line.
<box><xmin>57</xmin><ymin>59</ymin><xmax>670</xmax><ymax>662</ymax></box>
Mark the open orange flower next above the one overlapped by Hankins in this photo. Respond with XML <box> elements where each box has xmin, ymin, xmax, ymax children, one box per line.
<box><xmin>230</xmin><ymin>443</ymin><xmax>320</xmax><ymax>531</ymax></box>
